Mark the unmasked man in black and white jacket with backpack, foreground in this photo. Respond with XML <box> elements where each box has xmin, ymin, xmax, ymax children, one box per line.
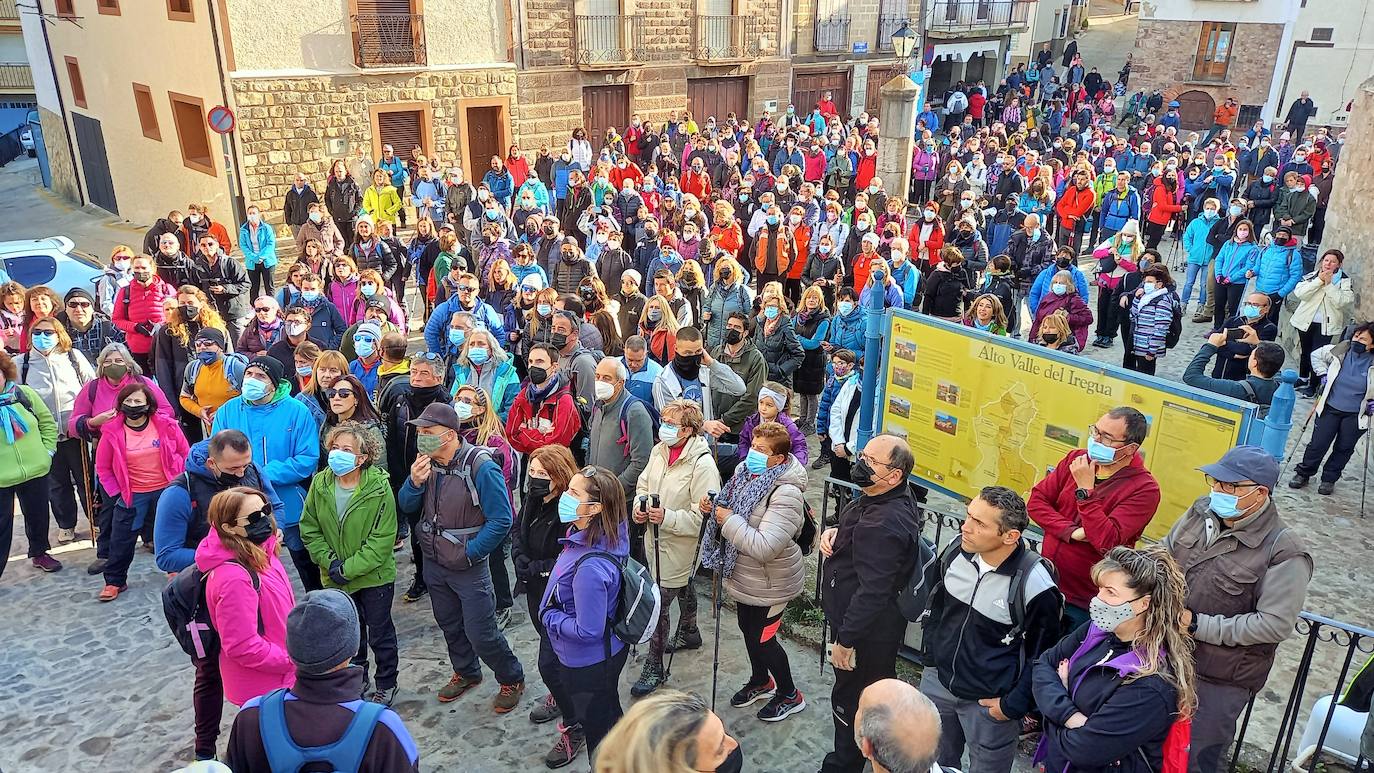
<box><xmin>921</xmin><ymin>486</ymin><xmax>1063</xmax><ymax>773</ymax></box>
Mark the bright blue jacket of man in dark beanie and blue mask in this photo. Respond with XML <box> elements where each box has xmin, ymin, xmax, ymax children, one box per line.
<box><xmin>210</xmin><ymin>380</ymin><xmax>320</xmax><ymax>538</ymax></box>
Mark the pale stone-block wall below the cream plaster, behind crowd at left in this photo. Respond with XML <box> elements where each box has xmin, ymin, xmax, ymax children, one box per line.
<box><xmin>232</xmin><ymin>69</ymin><xmax>519</xmax><ymax>224</ymax></box>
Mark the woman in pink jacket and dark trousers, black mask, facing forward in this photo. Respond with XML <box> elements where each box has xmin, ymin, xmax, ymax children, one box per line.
<box><xmin>95</xmin><ymin>382</ymin><xmax>191</xmax><ymax>601</ymax></box>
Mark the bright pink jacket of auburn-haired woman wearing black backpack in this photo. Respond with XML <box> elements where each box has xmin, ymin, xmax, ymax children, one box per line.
<box><xmin>195</xmin><ymin>529</ymin><xmax>295</xmax><ymax>706</ymax></box>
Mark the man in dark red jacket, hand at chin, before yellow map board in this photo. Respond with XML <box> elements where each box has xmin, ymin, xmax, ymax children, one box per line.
<box><xmin>1026</xmin><ymin>406</ymin><xmax>1160</xmax><ymax>627</ymax></box>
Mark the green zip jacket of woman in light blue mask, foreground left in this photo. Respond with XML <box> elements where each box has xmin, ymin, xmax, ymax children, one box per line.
<box><xmin>301</xmin><ymin>464</ymin><xmax>396</xmax><ymax>593</ymax></box>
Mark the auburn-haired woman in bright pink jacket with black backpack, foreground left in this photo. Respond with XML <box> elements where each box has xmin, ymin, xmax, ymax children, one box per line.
<box><xmin>195</xmin><ymin>486</ymin><xmax>295</xmax><ymax>714</ymax></box>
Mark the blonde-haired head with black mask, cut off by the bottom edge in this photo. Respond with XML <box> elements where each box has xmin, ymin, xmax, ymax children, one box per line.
<box><xmin>596</xmin><ymin>689</ymin><xmax>743</xmax><ymax>773</ymax></box>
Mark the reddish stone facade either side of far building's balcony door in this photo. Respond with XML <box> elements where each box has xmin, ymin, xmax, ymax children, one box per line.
<box><xmin>1131</xmin><ymin>16</ymin><xmax>1283</xmax><ymax>104</ymax></box>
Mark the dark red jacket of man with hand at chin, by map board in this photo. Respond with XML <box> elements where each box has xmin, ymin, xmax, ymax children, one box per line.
<box><xmin>1026</xmin><ymin>449</ymin><xmax>1160</xmax><ymax>610</ymax></box>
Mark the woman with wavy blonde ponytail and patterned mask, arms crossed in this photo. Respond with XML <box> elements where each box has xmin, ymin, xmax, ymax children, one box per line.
<box><xmin>1032</xmin><ymin>545</ymin><xmax>1197</xmax><ymax>773</ymax></box>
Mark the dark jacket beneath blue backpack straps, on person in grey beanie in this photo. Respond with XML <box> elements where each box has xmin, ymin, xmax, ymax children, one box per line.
<box><xmin>225</xmin><ymin>666</ymin><xmax>420</xmax><ymax>773</ymax></box>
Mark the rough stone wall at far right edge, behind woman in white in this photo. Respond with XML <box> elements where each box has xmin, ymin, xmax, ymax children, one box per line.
<box><xmin>1322</xmin><ymin>78</ymin><xmax>1374</xmax><ymax>321</ymax></box>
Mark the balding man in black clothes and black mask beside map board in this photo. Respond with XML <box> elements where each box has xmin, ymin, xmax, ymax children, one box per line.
<box><xmin>820</xmin><ymin>434</ymin><xmax>921</xmax><ymax>773</ymax></box>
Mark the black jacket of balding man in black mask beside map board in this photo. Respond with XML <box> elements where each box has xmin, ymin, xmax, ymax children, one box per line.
<box><xmin>820</xmin><ymin>486</ymin><xmax>921</xmax><ymax>647</ymax></box>
